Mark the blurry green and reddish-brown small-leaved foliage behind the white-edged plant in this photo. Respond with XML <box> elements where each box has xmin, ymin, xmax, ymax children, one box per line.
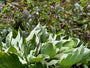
<box><xmin>0</xmin><ymin>0</ymin><xmax>90</xmax><ymax>46</ymax></box>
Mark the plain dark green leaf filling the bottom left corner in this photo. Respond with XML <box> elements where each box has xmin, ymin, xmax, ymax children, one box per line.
<box><xmin>0</xmin><ymin>52</ymin><xmax>23</xmax><ymax>68</ymax></box>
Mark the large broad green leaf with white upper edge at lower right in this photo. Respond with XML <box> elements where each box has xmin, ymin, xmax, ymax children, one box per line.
<box><xmin>59</xmin><ymin>46</ymin><xmax>85</xmax><ymax>67</ymax></box>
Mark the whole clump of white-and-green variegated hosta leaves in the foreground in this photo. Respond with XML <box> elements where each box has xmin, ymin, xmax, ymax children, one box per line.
<box><xmin>0</xmin><ymin>24</ymin><xmax>90</xmax><ymax>68</ymax></box>
